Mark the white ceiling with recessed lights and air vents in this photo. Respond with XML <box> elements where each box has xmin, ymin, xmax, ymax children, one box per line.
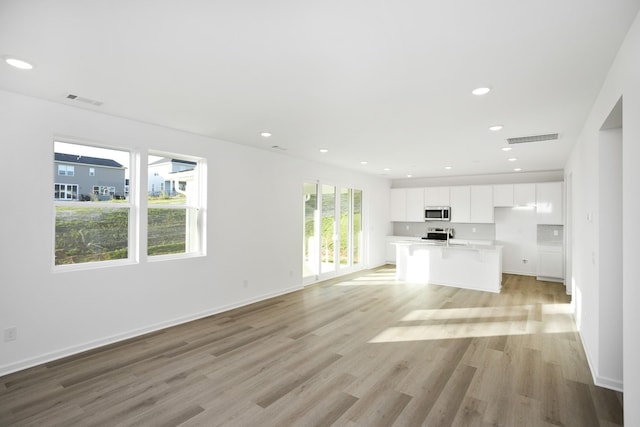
<box><xmin>0</xmin><ymin>0</ymin><xmax>640</xmax><ymax>178</ymax></box>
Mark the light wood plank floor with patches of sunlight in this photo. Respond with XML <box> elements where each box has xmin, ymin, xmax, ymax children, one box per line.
<box><xmin>0</xmin><ymin>266</ymin><xmax>622</xmax><ymax>427</ymax></box>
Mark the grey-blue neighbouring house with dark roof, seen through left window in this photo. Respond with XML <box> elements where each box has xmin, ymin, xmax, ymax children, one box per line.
<box><xmin>53</xmin><ymin>153</ymin><xmax>127</xmax><ymax>200</ymax></box>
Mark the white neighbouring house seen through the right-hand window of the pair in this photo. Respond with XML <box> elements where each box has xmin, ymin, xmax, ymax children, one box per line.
<box><xmin>147</xmin><ymin>158</ymin><xmax>197</xmax><ymax>196</ymax></box>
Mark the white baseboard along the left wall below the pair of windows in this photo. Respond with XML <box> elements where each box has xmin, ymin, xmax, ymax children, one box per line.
<box><xmin>0</xmin><ymin>286</ymin><xmax>303</xmax><ymax>376</ymax></box>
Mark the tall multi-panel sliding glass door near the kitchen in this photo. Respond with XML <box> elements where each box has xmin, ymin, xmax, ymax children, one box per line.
<box><xmin>303</xmin><ymin>182</ymin><xmax>363</xmax><ymax>283</ymax></box>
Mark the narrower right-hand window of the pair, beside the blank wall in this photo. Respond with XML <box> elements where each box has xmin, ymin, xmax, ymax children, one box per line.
<box><xmin>147</xmin><ymin>153</ymin><xmax>203</xmax><ymax>257</ymax></box>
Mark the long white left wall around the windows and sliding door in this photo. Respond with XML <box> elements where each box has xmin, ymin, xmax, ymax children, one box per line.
<box><xmin>0</xmin><ymin>91</ymin><xmax>391</xmax><ymax>375</ymax></box>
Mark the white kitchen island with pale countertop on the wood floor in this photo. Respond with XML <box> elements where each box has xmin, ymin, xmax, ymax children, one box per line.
<box><xmin>394</xmin><ymin>240</ymin><xmax>502</xmax><ymax>292</ymax></box>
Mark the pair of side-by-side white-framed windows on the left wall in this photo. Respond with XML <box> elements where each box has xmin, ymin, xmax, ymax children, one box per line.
<box><xmin>53</xmin><ymin>142</ymin><xmax>204</xmax><ymax>269</ymax></box>
